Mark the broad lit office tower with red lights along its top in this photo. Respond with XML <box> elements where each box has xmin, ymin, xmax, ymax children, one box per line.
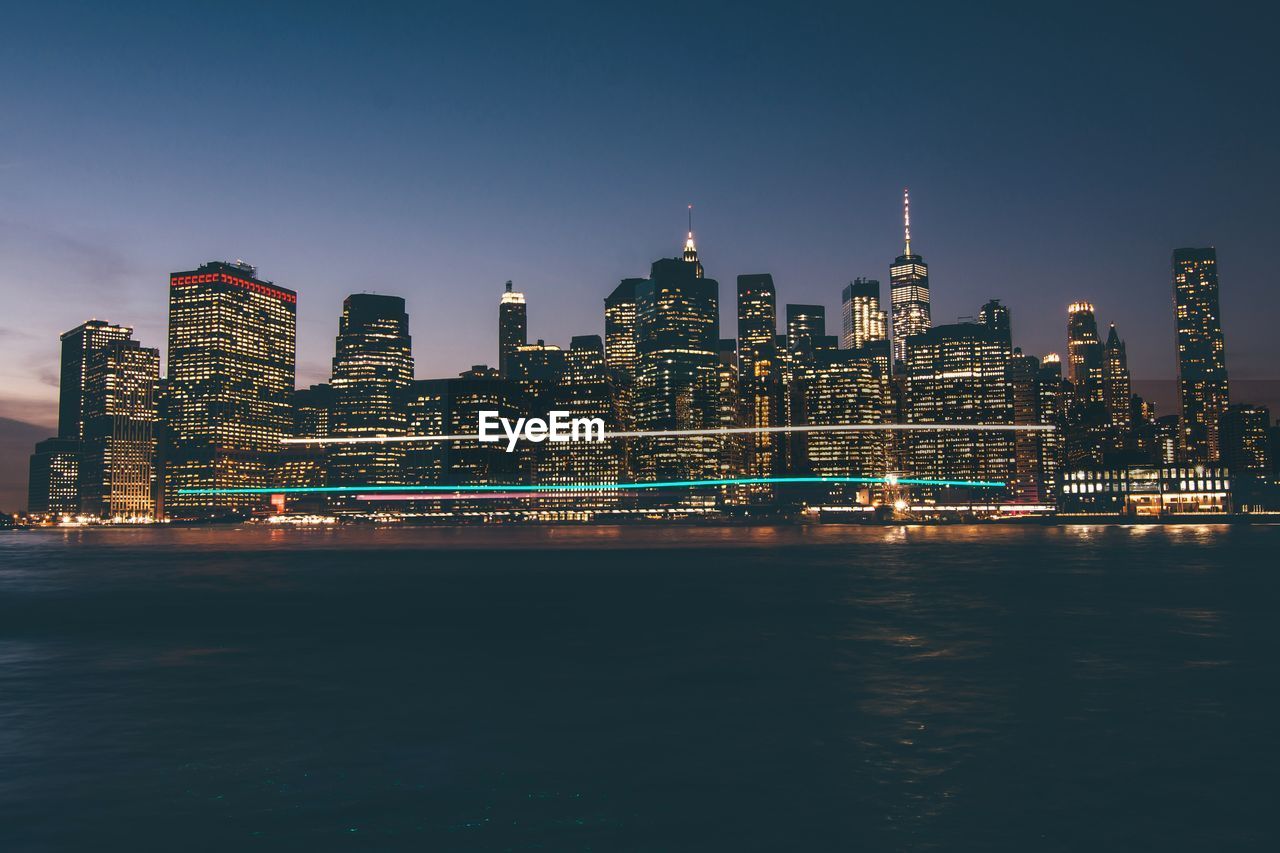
<box><xmin>164</xmin><ymin>261</ymin><xmax>298</xmax><ymax>517</ymax></box>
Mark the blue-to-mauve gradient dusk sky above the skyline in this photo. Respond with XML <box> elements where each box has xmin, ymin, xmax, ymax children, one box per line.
<box><xmin>0</xmin><ymin>3</ymin><xmax>1280</xmax><ymax>425</ymax></box>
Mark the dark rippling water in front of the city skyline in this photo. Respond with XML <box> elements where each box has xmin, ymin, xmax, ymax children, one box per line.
<box><xmin>0</xmin><ymin>526</ymin><xmax>1280</xmax><ymax>850</ymax></box>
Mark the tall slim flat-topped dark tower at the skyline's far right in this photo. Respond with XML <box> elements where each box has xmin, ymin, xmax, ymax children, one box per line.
<box><xmin>1174</xmin><ymin>248</ymin><xmax>1229</xmax><ymax>462</ymax></box>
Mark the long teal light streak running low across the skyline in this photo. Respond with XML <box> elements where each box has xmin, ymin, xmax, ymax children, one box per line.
<box><xmin>178</xmin><ymin>476</ymin><xmax>1005</xmax><ymax>494</ymax></box>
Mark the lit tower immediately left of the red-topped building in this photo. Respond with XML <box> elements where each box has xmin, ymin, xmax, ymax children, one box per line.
<box><xmin>79</xmin><ymin>339</ymin><xmax>160</xmax><ymax>519</ymax></box>
